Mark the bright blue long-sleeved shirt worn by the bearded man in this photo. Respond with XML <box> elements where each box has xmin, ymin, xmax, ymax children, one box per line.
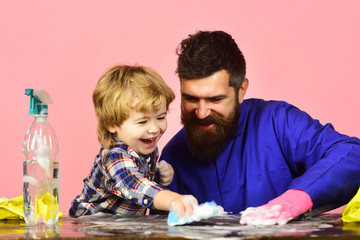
<box><xmin>161</xmin><ymin>99</ymin><xmax>360</xmax><ymax>213</ymax></box>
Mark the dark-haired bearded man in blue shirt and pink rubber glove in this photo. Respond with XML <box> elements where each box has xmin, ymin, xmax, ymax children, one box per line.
<box><xmin>161</xmin><ymin>31</ymin><xmax>360</xmax><ymax>224</ymax></box>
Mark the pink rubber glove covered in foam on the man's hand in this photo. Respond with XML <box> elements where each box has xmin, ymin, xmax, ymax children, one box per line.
<box><xmin>240</xmin><ymin>189</ymin><xmax>313</xmax><ymax>225</ymax></box>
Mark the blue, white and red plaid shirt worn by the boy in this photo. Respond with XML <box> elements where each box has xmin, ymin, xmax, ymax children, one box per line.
<box><xmin>69</xmin><ymin>138</ymin><xmax>163</xmax><ymax>217</ymax></box>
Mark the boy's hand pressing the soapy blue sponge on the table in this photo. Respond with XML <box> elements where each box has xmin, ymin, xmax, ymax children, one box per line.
<box><xmin>170</xmin><ymin>195</ymin><xmax>199</xmax><ymax>218</ymax></box>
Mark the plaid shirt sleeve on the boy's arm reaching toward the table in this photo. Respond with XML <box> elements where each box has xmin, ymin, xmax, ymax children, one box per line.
<box><xmin>103</xmin><ymin>146</ymin><xmax>163</xmax><ymax>208</ymax></box>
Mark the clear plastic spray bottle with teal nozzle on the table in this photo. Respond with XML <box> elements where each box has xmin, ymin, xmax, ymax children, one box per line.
<box><xmin>23</xmin><ymin>89</ymin><xmax>59</xmax><ymax>225</ymax></box>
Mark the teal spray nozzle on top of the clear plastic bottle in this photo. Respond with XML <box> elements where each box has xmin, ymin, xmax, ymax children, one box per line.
<box><xmin>25</xmin><ymin>88</ymin><xmax>53</xmax><ymax>115</ymax></box>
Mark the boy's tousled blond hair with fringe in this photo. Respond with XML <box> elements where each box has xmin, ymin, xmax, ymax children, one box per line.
<box><xmin>93</xmin><ymin>65</ymin><xmax>175</xmax><ymax>148</ymax></box>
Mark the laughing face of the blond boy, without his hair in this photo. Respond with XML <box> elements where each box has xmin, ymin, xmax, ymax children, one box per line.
<box><xmin>109</xmin><ymin>103</ymin><xmax>167</xmax><ymax>155</ymax></box>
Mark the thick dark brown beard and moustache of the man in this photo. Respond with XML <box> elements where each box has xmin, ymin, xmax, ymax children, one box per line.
<box><xmin>181</xmin><ymin>103</ymin><xmax>240</xmax><ymax>161</ymax></box>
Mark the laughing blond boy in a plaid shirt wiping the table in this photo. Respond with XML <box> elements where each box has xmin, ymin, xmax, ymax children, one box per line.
<box><xmin>69</xmin><ymin>65</ymin><xmax>198</xmax><ymax>217</ymax></box>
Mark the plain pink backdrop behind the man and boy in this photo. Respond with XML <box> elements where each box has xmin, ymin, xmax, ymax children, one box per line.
<box><xmin>0</xmin><ymin>0</ymin><xmax>360</xmax><ymax>214</ymax></box>
